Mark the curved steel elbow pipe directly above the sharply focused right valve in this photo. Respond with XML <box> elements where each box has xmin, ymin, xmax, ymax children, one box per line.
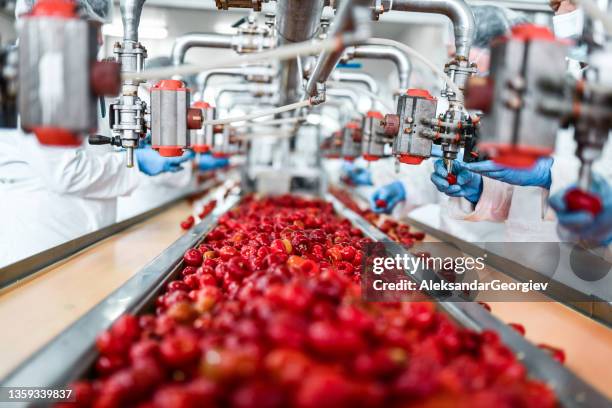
<box><xmin>344</xmin><ymin>39</ymin><xmax>412</xmax><ymax>90</ymax></box>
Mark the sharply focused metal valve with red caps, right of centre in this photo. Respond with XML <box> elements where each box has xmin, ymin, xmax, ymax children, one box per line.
<box><xmin>383</xmin><ymin>89</ymin><xmax>438</xmax><ymax>164</ymax></box>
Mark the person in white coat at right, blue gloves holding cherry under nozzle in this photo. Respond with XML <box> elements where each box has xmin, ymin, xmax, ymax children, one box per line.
<box><xmin>432</xmin><ymin>1</ymin><xmax>612</xmax><ymax>242</ymax></box>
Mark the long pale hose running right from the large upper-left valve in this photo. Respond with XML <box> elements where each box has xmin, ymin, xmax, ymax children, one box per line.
<box><xmin>121</xmin><ymin>36</ymin><xmax>346</xmax><ymax>80</ymax></box>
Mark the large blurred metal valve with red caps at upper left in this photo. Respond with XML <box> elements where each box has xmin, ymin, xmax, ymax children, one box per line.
<box><xmin>18</xmin><ymin>0</ymin><xmax>121</xmax><ymax>146</ymax></box>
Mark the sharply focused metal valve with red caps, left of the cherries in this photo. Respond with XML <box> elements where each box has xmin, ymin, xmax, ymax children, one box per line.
<box><xmin>151</xmin><ymin>79</ymin><xmax>203</xmax><ymax>157</ymax></box>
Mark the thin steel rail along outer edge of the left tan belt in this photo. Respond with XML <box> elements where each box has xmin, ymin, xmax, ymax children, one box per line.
<box><xmin>0</xmin><ymin>180</ymin><xmax>217</xmax><ymax>289</ymax></box>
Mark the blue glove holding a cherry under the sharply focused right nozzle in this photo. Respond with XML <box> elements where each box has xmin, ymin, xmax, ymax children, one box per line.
<box><xmin>431</xmin><ymin>160</ymin><xmax>482</xmax><ymax>204</ymax></box>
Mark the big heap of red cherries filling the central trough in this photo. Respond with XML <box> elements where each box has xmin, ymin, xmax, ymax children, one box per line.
<box><xmin>61</xmin><ymin>196</ymin><xmax>556</xmax><ymax>408</ymax></box>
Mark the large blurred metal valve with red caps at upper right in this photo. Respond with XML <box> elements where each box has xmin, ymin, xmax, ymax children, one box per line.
<box><xmin>466</xmin><ymin>24</ymin><xmax>567</xmax><ymax>167</ymax></box>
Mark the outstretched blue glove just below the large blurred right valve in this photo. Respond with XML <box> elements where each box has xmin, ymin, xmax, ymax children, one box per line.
<box><xmin>465</xmin><ymin>157</ymin><xmax>554</xmax><ymax>190</ymax></box>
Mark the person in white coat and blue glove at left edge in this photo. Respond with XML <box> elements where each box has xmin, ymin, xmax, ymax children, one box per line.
<box><xmin>0</xmin><ymin>0</ymin><xmax>194</xmax><ymax>267</ymax></box>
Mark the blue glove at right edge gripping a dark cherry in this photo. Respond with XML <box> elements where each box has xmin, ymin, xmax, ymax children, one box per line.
<box><xmin>550</xmin><ymin>175</ymin><xmax>612</xmax><ymax>245</ymax></box>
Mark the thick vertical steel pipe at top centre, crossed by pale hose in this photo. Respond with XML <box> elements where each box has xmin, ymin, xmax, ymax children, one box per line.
<box><xmin>276</xmin><ymin>0</ymin><xmax>324</xmax><ymax>104</ymax></box>
